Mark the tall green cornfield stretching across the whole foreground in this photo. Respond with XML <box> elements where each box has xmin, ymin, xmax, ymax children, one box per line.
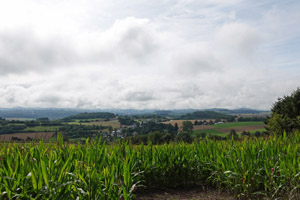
<box><xmin>0</xmin><ymin>134</ymin><xmax>300</xmax><ymax>200</ymax></box>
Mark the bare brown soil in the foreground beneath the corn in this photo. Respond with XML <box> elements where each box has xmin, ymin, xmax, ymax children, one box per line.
<box><xmin>136</xmin><ymin>188</ymin><xmax>236</xmax><ymax>200</ymax></box>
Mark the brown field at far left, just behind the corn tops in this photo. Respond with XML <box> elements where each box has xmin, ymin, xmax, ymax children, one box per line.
<box><xmin>0</xmin><ymin>132</ymin><xmax>55</xmax><ymax>142</ymax></box>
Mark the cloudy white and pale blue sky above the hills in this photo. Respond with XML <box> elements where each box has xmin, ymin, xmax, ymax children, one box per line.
<box><xmin>0</xmin><ymin>0</ymin><xmax>300</xmax><ymax>110</ymax></box>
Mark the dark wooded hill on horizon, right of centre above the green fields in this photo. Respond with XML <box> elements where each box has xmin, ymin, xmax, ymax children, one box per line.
<box><xmin>179</xmin><ymin>111</ymin><xmax>233</xmax><ymax>120</ymax></box>
